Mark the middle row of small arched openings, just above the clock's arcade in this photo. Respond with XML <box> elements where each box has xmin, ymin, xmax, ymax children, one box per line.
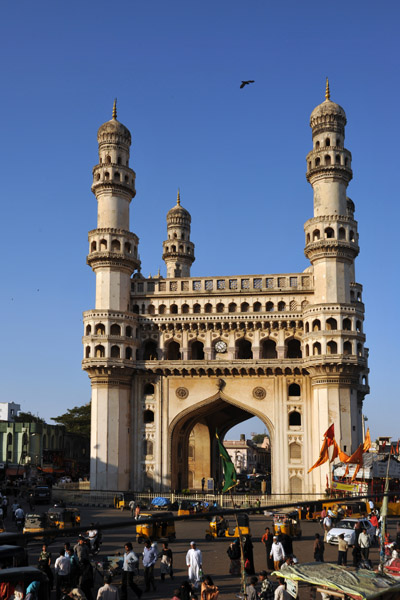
<box><xmin>132</xmin><ymin>300</ymin><xmax>308</xmax><ymax>315</ymax></box>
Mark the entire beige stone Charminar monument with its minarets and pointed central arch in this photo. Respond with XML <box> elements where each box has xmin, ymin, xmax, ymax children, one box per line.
<box><xmin>83</xmin><ymin>82</ymin><xmax>368</xmax><ymax>494</ymax></box>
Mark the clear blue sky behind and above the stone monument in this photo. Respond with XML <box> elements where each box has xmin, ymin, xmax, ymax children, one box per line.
<box><xmin>0</xmin><ymin>0</ymin><xmax>400</xmax><ymax>438</ymax></box>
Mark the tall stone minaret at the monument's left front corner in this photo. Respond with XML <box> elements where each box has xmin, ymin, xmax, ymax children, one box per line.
<box><xmin>83</xmin><ymin>103</ymin><xmax>140</xmax><ymax>490</ymax></box>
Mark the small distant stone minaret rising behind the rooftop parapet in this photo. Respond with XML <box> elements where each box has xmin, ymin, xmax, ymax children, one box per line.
<box><xmin>162</xmin><ymin>190</ymin><xmax>195</xmax><ymax>277</ymax></box>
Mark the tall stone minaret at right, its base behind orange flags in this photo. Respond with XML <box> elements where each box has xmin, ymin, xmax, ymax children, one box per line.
<box><xmin>303</xmin><ymin>80</ymin><xmax>368</xmax><ymax>489</ymax></box>
